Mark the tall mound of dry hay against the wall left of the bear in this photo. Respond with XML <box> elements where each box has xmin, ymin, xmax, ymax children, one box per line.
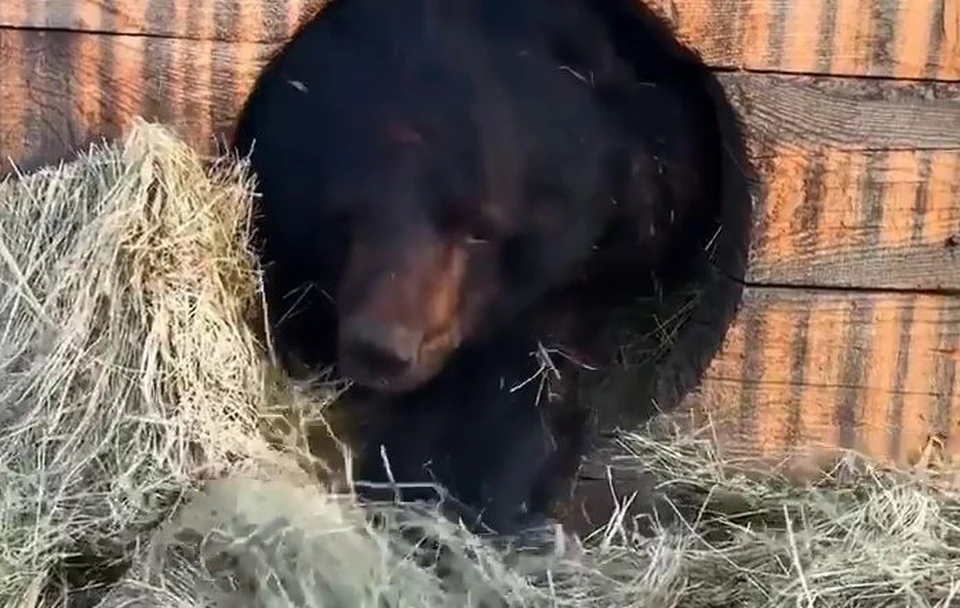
<box><xmin>0</xmin><ymin>124</ymin><xmax>310</xmax><ymax>598</ymax></box>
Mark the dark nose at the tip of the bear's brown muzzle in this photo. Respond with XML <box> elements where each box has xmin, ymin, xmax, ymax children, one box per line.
<box><xmin>340</xmin><ymin>319</ymin><xmax>423</xmax><ymax>386</ymax></box>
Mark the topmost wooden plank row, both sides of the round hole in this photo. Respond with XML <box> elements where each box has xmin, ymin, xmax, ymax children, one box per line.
<box><xmin>0</xmin><ymin>0</ymin><xmax>960</xmax><ymax>80</ymax></box>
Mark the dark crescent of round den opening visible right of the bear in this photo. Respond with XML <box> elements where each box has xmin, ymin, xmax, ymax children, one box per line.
<box><xmin>236</xmin><ymin>0</ymin><xmax>754</xmax><ymax>532</ymax></box>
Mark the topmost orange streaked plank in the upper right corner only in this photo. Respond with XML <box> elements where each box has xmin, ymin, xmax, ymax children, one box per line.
<box><xmin>647</xmin><ymin>0</ymin><xmax>960</xmax><ymax>80</ymax></box>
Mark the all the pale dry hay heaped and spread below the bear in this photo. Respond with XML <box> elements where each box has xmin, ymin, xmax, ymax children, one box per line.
<box><xmin>0</xmin><ymin>124</ymin><xmax>960</xmax><ymax>608</ymax></box>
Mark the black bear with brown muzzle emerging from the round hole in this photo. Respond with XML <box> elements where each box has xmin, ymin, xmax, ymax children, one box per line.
<box><xmin>235</xmin><ymin>0</ymin><xmax>752</xmax><ymax>532</ymax></box>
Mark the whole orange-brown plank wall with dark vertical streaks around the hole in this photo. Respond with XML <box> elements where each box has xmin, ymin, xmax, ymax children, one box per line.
<box><xmin>0</xmin><ymin>0</ymin><xmax>960</xmax><ymax>476</ymax></box>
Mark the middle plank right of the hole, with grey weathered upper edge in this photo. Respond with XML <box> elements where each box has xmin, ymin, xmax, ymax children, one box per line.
<box><xmin>719</xmin><ymin>74</ymin><xmax>960</xmax><ymax>290</ymax></box>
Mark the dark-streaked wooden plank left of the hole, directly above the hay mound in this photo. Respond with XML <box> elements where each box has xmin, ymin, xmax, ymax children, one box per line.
<box><xmin>0</xmin><ymin>30</ymin><xmax>277</xmax><ymax>174</ymax></box>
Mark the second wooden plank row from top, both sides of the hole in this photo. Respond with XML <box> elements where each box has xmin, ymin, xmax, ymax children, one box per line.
<box><xmin>0</xmin><ymin>30</ymin><xmax>960</xmax><ymax>290</ymax></box>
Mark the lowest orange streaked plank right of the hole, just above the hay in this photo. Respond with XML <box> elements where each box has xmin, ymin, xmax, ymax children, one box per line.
<box><xmin>668</xmin><ymin>288</ymin><xmax>960</xmax><ymax>476</ymax></box>
